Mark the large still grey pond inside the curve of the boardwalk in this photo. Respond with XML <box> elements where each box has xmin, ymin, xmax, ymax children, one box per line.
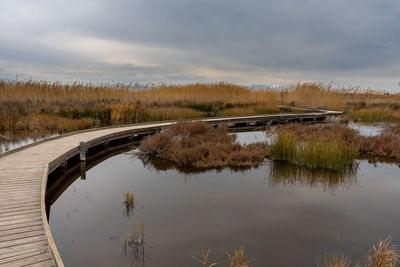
<box><xmin>49</xmin><ymin>133</ymin><xmax>400</xmax><ymax>266</ymax></box>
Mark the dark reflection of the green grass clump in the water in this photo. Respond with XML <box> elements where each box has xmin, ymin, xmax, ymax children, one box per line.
<box><xmin>267</xmin><ymin>161</ymin><xmax>358</xmax><ymax>194</ymax></box>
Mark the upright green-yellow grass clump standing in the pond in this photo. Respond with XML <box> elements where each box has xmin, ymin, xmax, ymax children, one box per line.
<box><xmin>270</xmin><ymin>128</ymin><xmax>358</xmax><ymax>171</ymax></box>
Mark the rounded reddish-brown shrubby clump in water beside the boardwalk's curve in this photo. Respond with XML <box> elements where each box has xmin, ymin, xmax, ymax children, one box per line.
<box><xmin>139</xmin><ymin>122</ymin><xmax>268</xmax><ymax>168</ymax></box>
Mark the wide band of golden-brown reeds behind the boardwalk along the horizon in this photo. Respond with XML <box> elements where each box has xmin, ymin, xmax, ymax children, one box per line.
<box><xmin>0</xmin><ymin>80</ymin><xmax>400</xmax><ymax>139</ymax></box>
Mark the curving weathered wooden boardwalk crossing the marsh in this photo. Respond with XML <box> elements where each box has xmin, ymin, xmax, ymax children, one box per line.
<box><xmin>0</xmin><ymin>108</ymin><xmax>342</xmax><ymax>266</ymax></box>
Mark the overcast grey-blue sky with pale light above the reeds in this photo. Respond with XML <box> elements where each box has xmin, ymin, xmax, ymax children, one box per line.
<box><xmin>0</xmin><ymin>0</ymin><xmax>400</xmax><ymax>91</ymax></box>
